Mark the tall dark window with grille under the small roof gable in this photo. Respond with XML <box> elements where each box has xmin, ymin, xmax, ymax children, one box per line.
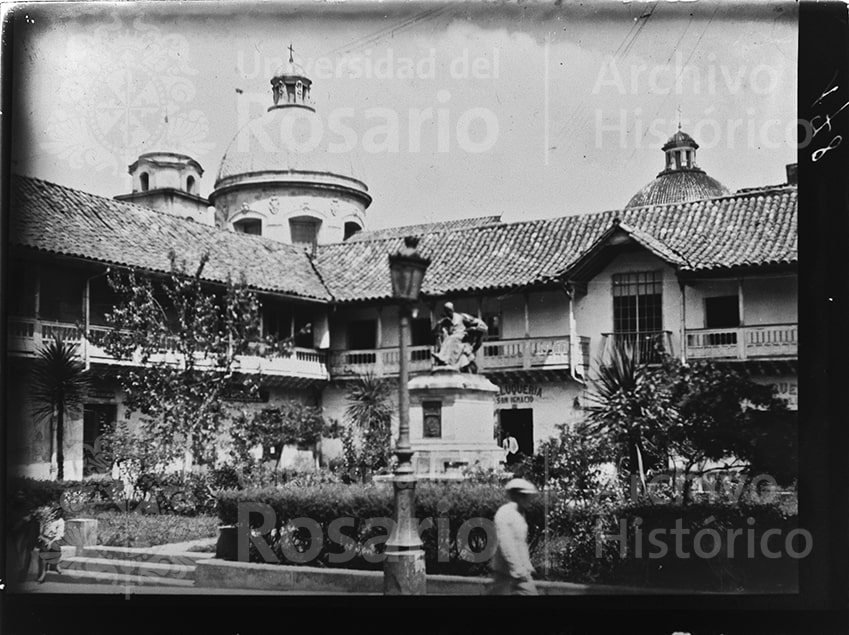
<box><xmin>613</xmin><ymin>271</ymin><xmax>663</xmax><ymax>334</ymax></box>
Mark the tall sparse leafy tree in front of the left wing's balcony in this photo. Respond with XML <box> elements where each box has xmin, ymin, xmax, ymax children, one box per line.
<box><xmin>103</xmin><ymin>252</ymin><xmax>292</xmax><ymax>470</ymax></box>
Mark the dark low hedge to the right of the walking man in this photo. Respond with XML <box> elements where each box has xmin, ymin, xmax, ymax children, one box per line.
<box><xmin>549</xmin><ymin>502</ymin><xmax>802</xmax><ymax>591</ymax></box>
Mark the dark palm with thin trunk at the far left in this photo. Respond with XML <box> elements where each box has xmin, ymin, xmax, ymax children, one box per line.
<box><xmin>31</xmin><ymin>334</ymin><xmax>91</xmax><ymax>481</ymax></box>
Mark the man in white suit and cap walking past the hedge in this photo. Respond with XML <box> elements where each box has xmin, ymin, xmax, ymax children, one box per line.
<box><xmin>489</xmin><ymin>478</ymin><xmax>539</xmax><ymax>595</ymax></box>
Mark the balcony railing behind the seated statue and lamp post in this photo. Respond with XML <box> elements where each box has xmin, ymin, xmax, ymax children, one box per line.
<box><xmin>330</xmin><ymin>337</ymin><xmax>590</xmax><ymax>377</ymax></box>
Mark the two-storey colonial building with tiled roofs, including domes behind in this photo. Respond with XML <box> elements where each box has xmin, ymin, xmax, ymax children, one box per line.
<box><xmin>7</xmin><ymin>57</ymin><xmax>798</xmax><ymax>478</ymax></box>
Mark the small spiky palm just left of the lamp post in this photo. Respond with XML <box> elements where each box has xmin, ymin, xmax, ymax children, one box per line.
<box><xmin>342</xmin><ymin>373</ymin><xmax>393</xmax><ymax>480</ymax></box>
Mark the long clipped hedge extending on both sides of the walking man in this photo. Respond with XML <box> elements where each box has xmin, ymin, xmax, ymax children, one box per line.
<box><xmin>217</xmin><ymin>483</ymin><xmax>805</xmax><ymax>591</ymax></box>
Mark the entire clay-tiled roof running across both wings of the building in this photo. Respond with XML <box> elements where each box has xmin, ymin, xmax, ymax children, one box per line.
<box><xmin>10</xmin><ymin>177</ymin><xmax>797</xmax><ymax>302</ymax></box>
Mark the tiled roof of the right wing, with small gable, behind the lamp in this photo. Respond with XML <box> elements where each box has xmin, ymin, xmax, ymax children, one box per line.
<box><xmin>316</xmin><ymin>187</ymin><xmax>797</xmax><ymax>301</ymax></box>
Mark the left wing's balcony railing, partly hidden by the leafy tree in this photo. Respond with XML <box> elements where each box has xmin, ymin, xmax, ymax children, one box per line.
<box><xmin>7</xmin><ymin>317</ymin><xmax>328</xmax><ymax>380</ymax></box>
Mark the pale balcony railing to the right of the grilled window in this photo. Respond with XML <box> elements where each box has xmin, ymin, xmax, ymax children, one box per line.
<box><xmin>686</xmin><ymin>324</ymin><xmax>799</xmax><ymax>360</ymax></box>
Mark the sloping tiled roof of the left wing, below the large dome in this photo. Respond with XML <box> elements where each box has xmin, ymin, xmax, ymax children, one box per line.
<box><xmin>9</xmin><ymin>176</ymin><xmax>330</xmax><ymax>300</ymax></box>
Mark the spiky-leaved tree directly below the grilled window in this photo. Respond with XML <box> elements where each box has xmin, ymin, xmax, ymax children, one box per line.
<box><xmin>586</xmin><ymin>341</ymin><xmax>674</xmax><ymax>500</ymax></box>
